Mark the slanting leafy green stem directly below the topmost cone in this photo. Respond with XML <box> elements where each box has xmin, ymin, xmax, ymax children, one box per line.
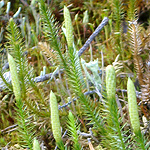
<box><xmin>62</xmin><ymin>5</ymin><xmax>105</xmax><ymax>138</ymax></box>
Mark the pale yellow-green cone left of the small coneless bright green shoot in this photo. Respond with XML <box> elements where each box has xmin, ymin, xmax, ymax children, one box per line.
<box><xmin>50</xmin><ymin>91</ymin><xmax>64</xmax><ymax>149</ymax></box>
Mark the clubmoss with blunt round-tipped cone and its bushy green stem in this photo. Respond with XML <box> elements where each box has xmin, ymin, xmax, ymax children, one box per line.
<box><xmin>106</xmin><ymin>65</ymin><xmax>127</xmax><ymax>150</ymax></box>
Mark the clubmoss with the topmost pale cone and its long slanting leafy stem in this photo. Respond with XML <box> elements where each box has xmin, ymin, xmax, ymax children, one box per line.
<box><xmin>64</xmin><ymin>5</ymin><xmax>106</xmax><ymax>133</ymax></box>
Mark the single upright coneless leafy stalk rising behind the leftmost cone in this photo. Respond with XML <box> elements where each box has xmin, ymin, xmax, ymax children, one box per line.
<box><xmin>6</xmin><ymin>18</ymin><xmax>27</xmax><ymax>99</ymax></box>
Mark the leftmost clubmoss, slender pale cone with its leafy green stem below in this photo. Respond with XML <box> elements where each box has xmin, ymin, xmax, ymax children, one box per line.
<box><xmin>8</xmin><ymin>53</ymin><xmax>33</xmax><ymax>149</ymax></box>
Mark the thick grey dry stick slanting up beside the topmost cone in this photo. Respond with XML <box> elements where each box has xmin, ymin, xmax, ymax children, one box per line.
<box><xmin>78</xmin><ymin>17</ymin><xmax>109</xmax><ymax>57</ymax></box>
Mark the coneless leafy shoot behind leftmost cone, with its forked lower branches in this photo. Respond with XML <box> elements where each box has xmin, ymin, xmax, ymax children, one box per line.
<box><xmin>6</xmin><ymin>18</ymin><xmax>46</xmax><ymax>114</ymax></box>
